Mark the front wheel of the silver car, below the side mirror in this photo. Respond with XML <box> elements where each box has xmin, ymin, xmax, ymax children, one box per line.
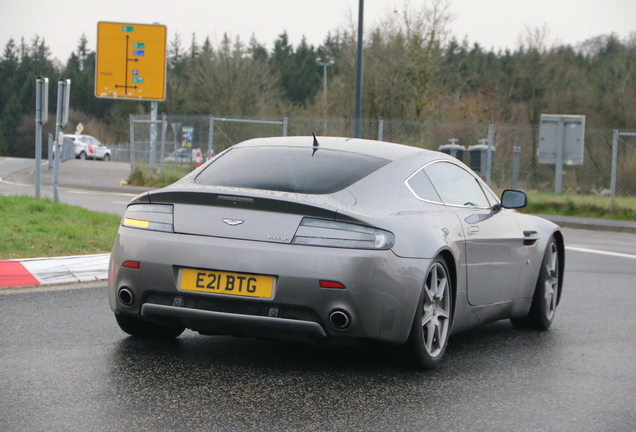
<box><xmin>510</xmin><ymin>237</ymin><xmax>560</xmax><ymax>330</ymax></box>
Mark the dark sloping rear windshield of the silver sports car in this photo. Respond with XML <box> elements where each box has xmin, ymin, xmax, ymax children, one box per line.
<box><xmin>195</xmin><ymin>147</ymin><xmax>389</xmax><ymax>194</ymax></box>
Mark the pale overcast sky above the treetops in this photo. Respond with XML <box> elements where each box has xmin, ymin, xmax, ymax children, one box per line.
<box><xmin>0</xmin><ymin>0</ymin><xmax>636</xmax><ymax>63</ymax></box>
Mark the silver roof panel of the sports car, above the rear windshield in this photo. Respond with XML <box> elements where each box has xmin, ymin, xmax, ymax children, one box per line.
<box><xmin>232</xmin><ymin>136</ymin><xmax>429</xmax><ymax>160</ymax></box>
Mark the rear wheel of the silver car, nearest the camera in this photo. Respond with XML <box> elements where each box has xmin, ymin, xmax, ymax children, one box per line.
<box><xmin>408</xmin><ymin>257</ymin><xmax>453</xmax><ymax>369</ymax></box>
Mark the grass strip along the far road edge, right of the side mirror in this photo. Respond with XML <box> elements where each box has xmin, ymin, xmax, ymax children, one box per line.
<box><xmin>522</xmin><ymin>192</ymin><xmax>636</xmax><ymax>221</ymax></box>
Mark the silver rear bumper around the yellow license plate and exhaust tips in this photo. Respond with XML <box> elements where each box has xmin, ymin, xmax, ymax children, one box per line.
<box><xmin>109</xmin><ymin>227</ymin><xmax>430</xmax><ymax>343</ymax></box>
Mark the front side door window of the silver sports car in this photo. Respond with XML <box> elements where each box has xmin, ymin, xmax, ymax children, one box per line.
<box><xmin>424</xmin><ymin>162</ymin><xmax>490</xmax><ymax>207</ymax></box>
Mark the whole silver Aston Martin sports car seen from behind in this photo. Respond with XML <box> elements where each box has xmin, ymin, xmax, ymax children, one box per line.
<box><xmin>108</xmin><ymin>137</ymin><xmax>565</xmax><ymax>368</ymax></box>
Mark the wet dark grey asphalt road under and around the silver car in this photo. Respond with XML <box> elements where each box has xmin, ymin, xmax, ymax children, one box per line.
<box><xmin>0</xmin><ymin>230</ymin><xmax>636</xmax><ymax>431</ymax></box>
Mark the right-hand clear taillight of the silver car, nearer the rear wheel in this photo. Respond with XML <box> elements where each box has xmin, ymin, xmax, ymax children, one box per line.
<box><xmin>292</xmin><ymin>218</ymin><xmax>395</xmax><ymax>250</ymax></box>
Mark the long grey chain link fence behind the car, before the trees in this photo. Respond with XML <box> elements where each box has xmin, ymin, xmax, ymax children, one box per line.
<box><xmin>112</xmin><ymin>115</ymin><xmax>636</xmax><ymax>202</ymax></box>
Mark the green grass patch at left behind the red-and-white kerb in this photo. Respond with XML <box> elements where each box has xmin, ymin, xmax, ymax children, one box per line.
<box><xmin>0</xmin><ymin>196</ymin><xmax>121</xmax><ymax>259</ymax></box>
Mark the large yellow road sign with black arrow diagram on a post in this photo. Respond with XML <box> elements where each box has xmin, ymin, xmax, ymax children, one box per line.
<box><xmin>95</xmin><ymin>22</ymin><xmax>167</xmax><ymax>100</ymax></box>
